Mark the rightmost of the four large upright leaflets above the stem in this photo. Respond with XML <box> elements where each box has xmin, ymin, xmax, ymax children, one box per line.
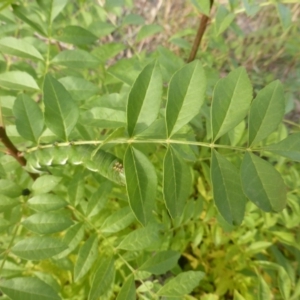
<box><xmin>249</xmin><ymin>80</ymin><xmax>285</xmax><ymax>147</ymax></box>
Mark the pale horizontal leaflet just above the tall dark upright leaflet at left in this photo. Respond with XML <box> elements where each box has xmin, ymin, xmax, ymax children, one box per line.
<box><xmin>51</xmin><ymin>49</ymin><xmax>100</xmax><ymax>69</ymax></box>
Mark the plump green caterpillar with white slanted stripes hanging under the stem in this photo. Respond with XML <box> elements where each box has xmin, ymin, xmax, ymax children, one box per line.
<box><xmin>26</xmin><ymin>145</ymin><xmax>125</xmax><ymax>185</ymax></box>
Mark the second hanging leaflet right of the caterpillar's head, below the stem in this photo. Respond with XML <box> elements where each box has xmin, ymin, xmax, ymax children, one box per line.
<box><xmin>163</xmin><ymin>147</ymin><xmax>192</xmax><ymax>219</ymax></box>
